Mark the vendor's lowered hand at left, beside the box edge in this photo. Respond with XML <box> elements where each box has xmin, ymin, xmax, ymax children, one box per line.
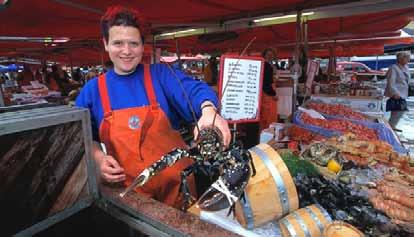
<box><xmin>96</xmin><ymin>154</ymin><xmax>126</xmax><ymax>183</ymax></box>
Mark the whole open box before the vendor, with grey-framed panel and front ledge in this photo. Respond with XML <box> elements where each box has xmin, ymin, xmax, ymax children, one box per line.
<box><xmin>0</xmin><ymin>106</ymin><xmax>239</xmax><ymax>237</ymax></box>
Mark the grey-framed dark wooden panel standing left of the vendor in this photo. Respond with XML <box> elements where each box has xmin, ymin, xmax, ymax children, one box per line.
<box><xmin>0</xmin><ymin>106</ymin><xmax>98</xmax><ymax>236</ymax></box>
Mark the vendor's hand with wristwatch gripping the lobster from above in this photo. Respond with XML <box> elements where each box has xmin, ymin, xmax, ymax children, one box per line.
<box><xmin>194</xmin><ymin>103</ymin><xmax>231</xmax><ymax>147</ymax></box>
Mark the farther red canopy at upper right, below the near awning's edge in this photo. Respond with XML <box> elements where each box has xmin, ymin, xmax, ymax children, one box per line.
<box><xmin>161</xmin><ymin>9</ymin><xmax>414</xmax><ymax>53</ymax></box>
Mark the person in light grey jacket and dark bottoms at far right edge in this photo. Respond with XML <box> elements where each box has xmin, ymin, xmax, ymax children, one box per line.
<box><xmin>384</xmin><ymin>51</ymin><xmax>411</xmax><ymax>131</ymax></box>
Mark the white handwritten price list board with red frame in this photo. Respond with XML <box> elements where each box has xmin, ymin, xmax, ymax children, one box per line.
<box><xmin>219</xmin><ymin>56</ymin><xmax>263</xmax><ymax>123</ymax></box>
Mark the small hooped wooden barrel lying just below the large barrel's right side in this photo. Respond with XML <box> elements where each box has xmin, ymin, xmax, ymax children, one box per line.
<box><xmin>279</xmin><ymin>205</ymin><xmax>332</xmax><ymax>237</ymax></box>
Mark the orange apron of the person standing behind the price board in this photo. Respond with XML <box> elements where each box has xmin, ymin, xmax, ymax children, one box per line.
<box><xmin>260</xmin><ymin>93</ymin><xmax>277</xmax><ymax>131</ymax></box>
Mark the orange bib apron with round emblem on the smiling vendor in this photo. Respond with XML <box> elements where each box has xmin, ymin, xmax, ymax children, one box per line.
<box><xmin>98</xmin><ymin>64</ymin><xmax>195</xmax><ymax>208</ymax></box>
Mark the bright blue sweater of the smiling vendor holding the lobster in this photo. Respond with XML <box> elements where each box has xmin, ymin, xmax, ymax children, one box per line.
<box><xmin>76</xmin><ymin>64</ymin><xmax>217</xmax><ymax>141</ymax></box>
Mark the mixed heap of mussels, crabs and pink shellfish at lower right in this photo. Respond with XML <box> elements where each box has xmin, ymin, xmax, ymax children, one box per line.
<box><xmin>294</xmin><ymin>134</ymin><xmax>414</xmax><ymax>236</ymax></box>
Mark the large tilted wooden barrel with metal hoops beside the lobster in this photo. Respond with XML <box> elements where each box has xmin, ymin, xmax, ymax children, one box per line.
<box><xmin>235</xmin><ymin>144</ymin><xmax>299</xmax><ymax>229</ymax></box>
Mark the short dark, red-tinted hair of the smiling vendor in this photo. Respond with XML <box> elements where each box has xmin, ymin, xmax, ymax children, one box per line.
<box><xmin>101</xmin><ymin>5</ymin><xmax>144</xmax><ymax>43</ymax></box>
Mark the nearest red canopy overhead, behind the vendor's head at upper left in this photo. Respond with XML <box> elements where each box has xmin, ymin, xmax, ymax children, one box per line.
<box><xmin>0</xmin><ymin>0</ymin><xmax>362</xmax><ymax>38</ymax></box>
